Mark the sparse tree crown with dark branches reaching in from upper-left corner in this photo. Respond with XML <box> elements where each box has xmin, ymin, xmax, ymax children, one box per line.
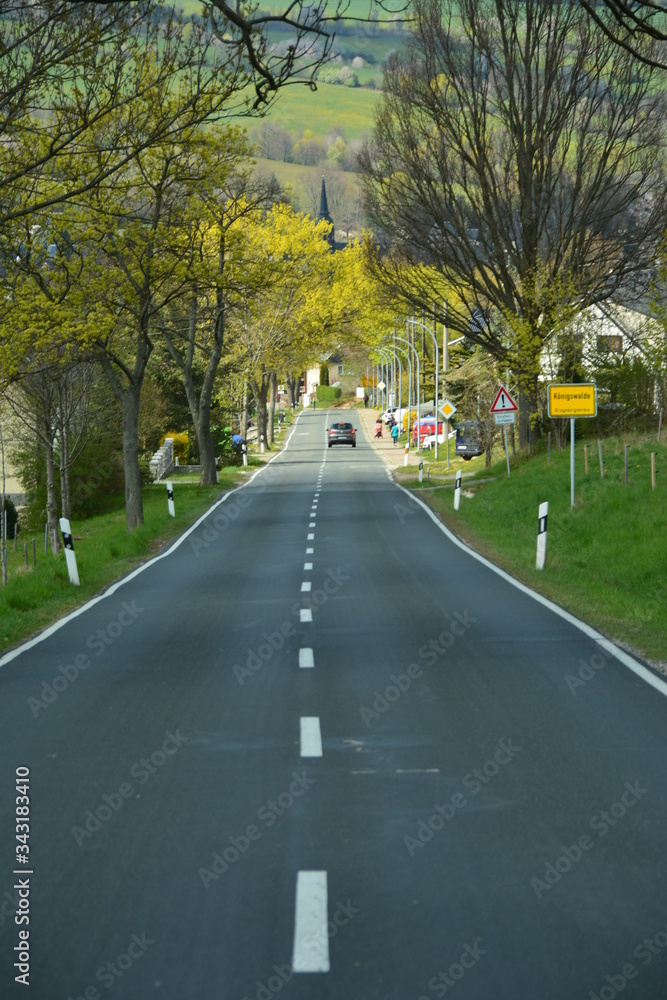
<box><xmin>0</xmin><ymin>0</ymin><xmax>249</xmax><ymax>236</ymax></box>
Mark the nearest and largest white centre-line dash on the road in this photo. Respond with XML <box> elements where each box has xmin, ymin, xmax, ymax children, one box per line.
<box><xmin>292</xmin><ymin>871</ymin><xmax>330</xmax><ymax>973</ymax></box>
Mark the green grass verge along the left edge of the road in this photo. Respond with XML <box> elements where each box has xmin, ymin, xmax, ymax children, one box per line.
<box><xmin>0</xmin><ymin>458</ymin><xmax>263</xmax><ymax>650</ymax></box>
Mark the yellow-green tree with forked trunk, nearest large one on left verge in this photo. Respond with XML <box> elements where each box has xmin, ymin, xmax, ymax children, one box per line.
<box><xmin>0</xmin><ymin>13</ymin><xmax>268</xmax><ymax>530</ymax></box>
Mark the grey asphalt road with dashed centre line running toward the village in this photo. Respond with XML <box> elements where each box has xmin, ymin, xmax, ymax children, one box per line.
<box><xmin>0</xmin><ymin>411</ymin><xmax>667</xmax><ymax>1000</ymax></box>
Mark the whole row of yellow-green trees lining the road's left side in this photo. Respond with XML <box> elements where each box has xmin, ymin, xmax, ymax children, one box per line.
<box><xmin>0</xmin><ymin>2</ymin><xmax>396</xmax><ymax>545</ymax></box>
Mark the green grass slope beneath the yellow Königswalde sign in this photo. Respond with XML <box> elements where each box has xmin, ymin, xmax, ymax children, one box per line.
<box><xmin>400</xmin><ymin>436</ymin><xmax>667</xmax><ymax>661</ymax></box>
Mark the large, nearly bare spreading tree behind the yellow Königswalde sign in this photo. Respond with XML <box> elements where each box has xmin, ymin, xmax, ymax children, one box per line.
<box><xmin>360</xmin><ymin>0</ymin><xmax>667</xmax><ymax>442</ymax></box>
